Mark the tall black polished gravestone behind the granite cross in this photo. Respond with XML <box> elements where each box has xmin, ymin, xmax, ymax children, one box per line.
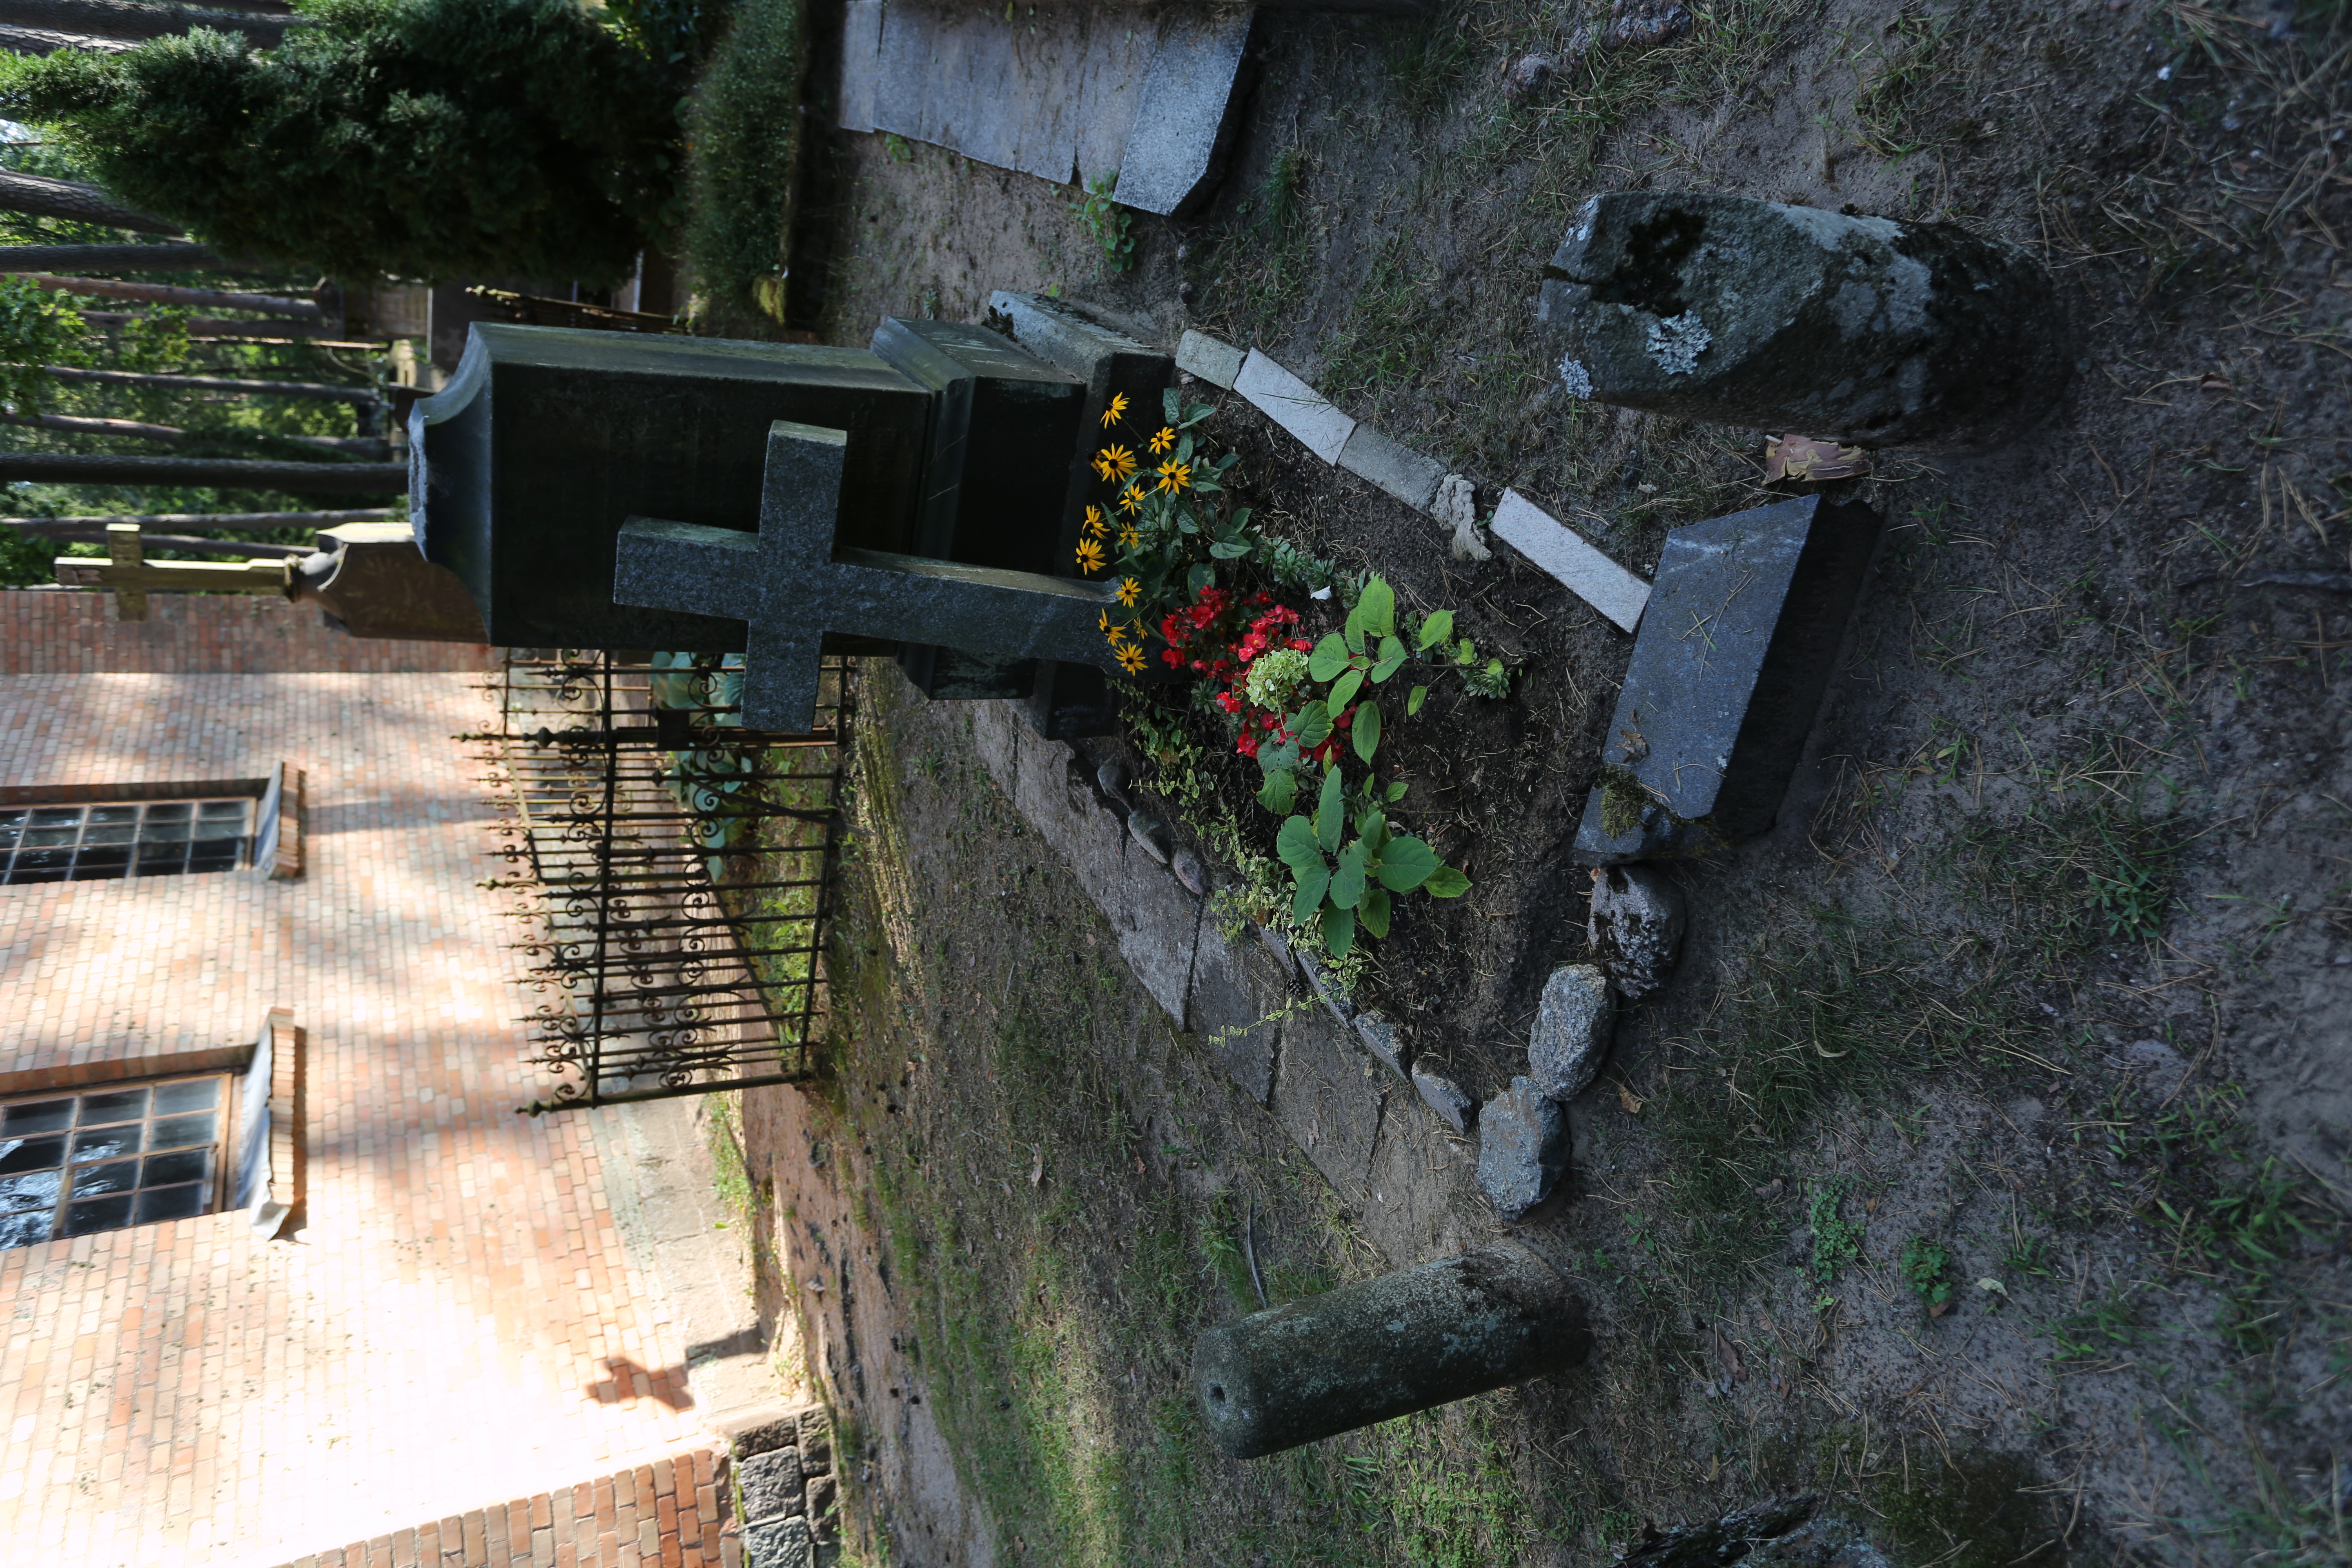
<box><xmin>409</xmin><ymin>320</ymin><xmax>1166</xmax><ymax>733</ymax></box>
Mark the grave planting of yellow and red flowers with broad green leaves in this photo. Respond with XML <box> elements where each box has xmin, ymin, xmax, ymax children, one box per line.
<box><xmin>1077</xmin><ymin>390</ymin><xmax>1510</xmax><ymax>966</ymax></box>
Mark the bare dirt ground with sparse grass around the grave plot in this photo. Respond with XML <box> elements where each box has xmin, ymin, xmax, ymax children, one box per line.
<box><xmin>738</xmin><ymin>0</ymin><xmax>2352</xmax><ymax>1566</ymax></box>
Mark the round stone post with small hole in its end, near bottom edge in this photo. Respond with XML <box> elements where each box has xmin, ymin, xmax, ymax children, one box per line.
<box><xmin>1192</xmin><ymin>1241</ymin><xmax>1592</xmax><ymax>1460</ymax></box>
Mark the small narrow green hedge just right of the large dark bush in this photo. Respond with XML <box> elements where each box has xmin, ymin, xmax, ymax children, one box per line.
<box><xmin>682</xmin><ymin>0</ymin><xmax>809</xmax><ymax>332</ymax></box>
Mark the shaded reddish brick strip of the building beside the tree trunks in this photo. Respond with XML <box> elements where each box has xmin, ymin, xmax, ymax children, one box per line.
<box><xmin>0</xmin><ymin>588</ymin><xmax>496</xmax><ymax>675</ymax></box>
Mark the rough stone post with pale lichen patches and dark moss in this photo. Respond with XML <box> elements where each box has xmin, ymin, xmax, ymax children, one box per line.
<box><xmin>1538</xmin><ymin>190</ymin><xmax>2074</xmax><ymax>451</ymax></box>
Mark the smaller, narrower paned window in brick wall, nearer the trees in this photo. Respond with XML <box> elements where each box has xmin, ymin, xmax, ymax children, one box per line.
<box><xmin>0</xmin><ymin>797</ymin><xmax>254</xmax><ymax>886</ymax></box>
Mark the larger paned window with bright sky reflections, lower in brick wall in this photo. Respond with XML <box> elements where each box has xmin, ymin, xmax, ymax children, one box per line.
<box><xmin>0</xmin><ymin>1072</ymin><xmax>228</xmax><ymax>1248</ymax></box>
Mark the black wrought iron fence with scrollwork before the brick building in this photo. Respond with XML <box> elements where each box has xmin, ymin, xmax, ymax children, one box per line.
<box><xmin>466</xmin><ymin>649</ymin><xmax>851</xmax><ymax>1117</ymax></box>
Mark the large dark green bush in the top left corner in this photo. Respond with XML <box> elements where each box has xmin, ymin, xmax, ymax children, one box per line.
<box><xmin>0</xmin><ymin>0</ymin><xmax>677</xmax><ymax>282</ymax></box>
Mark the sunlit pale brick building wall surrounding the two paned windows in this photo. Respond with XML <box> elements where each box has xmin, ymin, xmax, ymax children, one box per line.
<box><xmin>0</xmin><ymin>668</ymin><xmax>701</xmax><ymax>1568</ymax></box>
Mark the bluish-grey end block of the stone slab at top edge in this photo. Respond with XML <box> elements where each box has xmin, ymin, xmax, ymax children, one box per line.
<box><xmin>1115</xmin><ymin>7</ymin><xmax>1256</xmax><ymax>218</ymax></box>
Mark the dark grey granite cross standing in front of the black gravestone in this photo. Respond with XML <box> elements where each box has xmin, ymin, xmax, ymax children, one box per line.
<box><xmin>612</xmin><ymin>419</ymin><xmax>1117</xmax><ymax>733</ymax></box>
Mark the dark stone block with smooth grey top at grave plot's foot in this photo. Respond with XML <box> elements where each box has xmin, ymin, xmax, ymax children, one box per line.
<box><xmin>1576</xmin><ymin>496</ymin><xmax>1879</xmax><ymax>865</ymax></box>
